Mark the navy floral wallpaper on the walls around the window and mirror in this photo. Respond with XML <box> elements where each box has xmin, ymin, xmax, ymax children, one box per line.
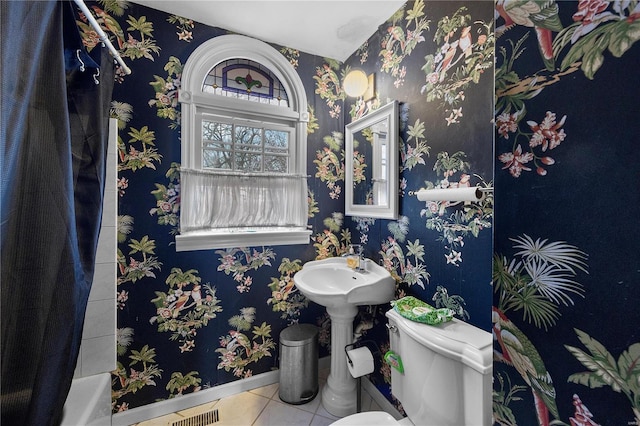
<box><xmin>78</xmin><ymin>0</ymin><xmax>495</xmax><ymax>412</ymax></box>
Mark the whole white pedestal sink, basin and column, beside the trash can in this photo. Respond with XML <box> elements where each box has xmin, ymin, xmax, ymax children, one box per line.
<box><xmin>293</xmin><ymin>257</ymin><xmax>395</xmax><ymax>417</ymax></box>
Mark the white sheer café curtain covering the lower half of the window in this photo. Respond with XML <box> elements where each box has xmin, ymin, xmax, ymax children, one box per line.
<box><xmin>180</xmin><ymin>169</ymin><xmax>308</xmax><ymax>233</ymax></box>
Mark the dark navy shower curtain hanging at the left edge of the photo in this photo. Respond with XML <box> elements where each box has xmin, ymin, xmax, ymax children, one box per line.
<box><xmin>0</xmin><ymin>0</ymin><xmax>114</xmax><ymax>426</ymax></box>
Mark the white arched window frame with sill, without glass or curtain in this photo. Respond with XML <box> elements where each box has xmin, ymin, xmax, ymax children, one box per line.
<box><xmin>176</xmin><ymin>34</ymin><xmax>311</xmax><ymax>251</ymax></box>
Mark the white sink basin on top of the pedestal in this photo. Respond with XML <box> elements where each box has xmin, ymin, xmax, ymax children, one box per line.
<box><xmin>293</xmin><ymin>257</ymin><xmax>395</xmax><ymax>307</ymax></box>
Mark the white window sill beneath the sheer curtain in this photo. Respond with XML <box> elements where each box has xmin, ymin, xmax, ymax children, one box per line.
<box><xmin>176</xmin><ymin>227</ymin><xmax>311</xmax><ymax>251</ymax></box>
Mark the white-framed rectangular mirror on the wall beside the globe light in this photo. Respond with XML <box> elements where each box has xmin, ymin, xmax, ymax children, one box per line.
<box><xmin>345</xmin><ymin>101</ymin><xmax>399</xmax><ymax>219</ymax></box>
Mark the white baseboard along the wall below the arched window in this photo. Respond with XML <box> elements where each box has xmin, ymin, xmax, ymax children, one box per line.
<box><xmin>111</xmin><ymin>357</ymin><xmax>332</xmax><ymax>426</ymax></box>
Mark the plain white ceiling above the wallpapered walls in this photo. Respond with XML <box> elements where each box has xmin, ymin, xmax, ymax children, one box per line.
<box><xmin>133</xmin><ymin>0</ymin><xmax>405</xmax><ymax>61</ymax></box>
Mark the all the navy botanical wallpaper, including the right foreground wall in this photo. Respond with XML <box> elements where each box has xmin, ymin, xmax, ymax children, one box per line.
<box><xmin>3</xmin><ymin>1</ymin><xmax>640</xmax><ymax>425</ymax></box>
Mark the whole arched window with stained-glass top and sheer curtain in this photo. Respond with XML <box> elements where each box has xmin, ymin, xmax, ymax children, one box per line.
<box><xmin>176</xmin><ymin>35</ymin><xmax>311</xmax><ymax>251</ymax></box>
